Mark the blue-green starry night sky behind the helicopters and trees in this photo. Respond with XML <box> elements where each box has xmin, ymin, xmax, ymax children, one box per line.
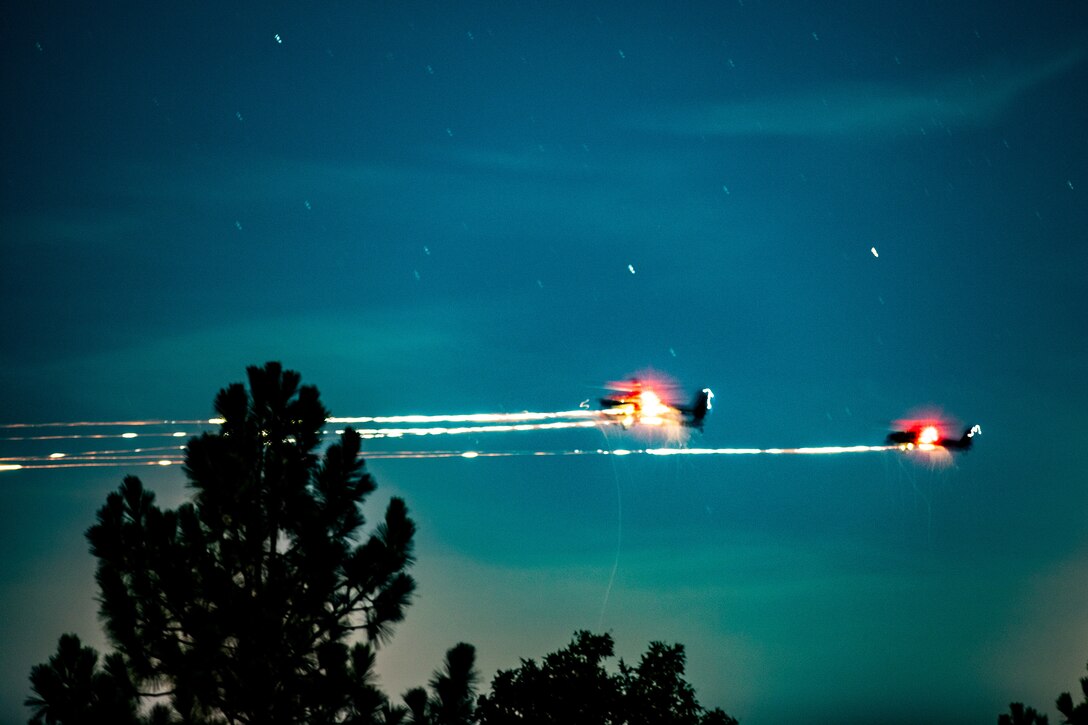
<box><xmin>0</xmin><ymin>0</ymin><xmax>1088</xmax><ymax>725</ymax></box>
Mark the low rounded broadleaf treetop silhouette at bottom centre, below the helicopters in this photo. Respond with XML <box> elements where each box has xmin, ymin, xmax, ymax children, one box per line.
<box><xmin>477</xmin><ymin>631</ymin><xmax>738</xmax><ymax>725</ymax></box>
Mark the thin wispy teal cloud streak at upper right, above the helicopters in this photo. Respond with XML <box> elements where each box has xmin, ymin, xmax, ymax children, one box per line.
<box><xmin>636</xmin><ymin>50</ymin><xmax>1084</xmax><ymax>138</ymax></box>
